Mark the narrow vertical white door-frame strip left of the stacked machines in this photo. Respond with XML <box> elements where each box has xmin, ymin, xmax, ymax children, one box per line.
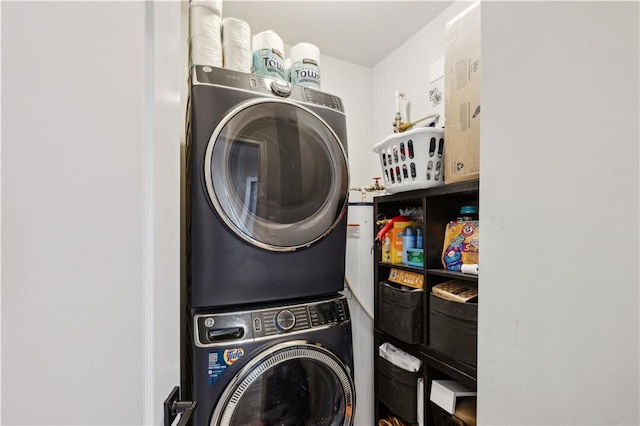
<box><xmin>149</xmin><ymin>0</ymin><xmax>181</xmax><ymax>425</ymax></box>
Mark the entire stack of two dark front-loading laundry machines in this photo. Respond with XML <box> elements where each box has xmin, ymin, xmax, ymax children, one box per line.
<box><xmin>183</xmin><ymin>66</ymin><xmax>355</xmax><ymax>426</ymax></box>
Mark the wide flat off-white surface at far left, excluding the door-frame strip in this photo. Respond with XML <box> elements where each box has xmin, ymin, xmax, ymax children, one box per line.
<box><xmin>2</xmin><ymin>2</ymin><xmax>145</xmax><ymax>424</ymax></box>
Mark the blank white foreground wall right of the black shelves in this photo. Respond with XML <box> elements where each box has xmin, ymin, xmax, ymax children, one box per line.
<box><xmin>478</xmin><ymin>2</ymin><xmax>640</xmax><ymax>425</ymax></box>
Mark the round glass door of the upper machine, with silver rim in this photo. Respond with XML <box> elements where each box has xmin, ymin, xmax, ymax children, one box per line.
<box><xmin>204</xmin><ymin>99</ymin><xmax>349</xmax><ymax>251</ymax></box>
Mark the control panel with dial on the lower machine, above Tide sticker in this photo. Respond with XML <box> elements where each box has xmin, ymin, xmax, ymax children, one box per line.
<box><xmin>194</xmin><ymin>296</ymin><xmax>350</xmax><ymax>347</ymax></box>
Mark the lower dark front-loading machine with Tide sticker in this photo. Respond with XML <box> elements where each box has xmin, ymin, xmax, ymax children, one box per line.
<box><xmin>189</xmin><ymin>295</ymin><xmax>356</xmax><ymax>426</ymax></box>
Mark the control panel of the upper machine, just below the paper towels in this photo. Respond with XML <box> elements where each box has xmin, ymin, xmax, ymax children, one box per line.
<box><xmin>191</xmin><ymin>65</ymin><xmax>344</xmax><ymax>112</ymax></box>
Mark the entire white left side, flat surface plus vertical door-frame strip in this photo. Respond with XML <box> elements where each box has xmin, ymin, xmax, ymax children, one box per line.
<box><xmin>1</xmin><ymin>2</ymin><xmax>183</xmax><ymax>425</ymax></box>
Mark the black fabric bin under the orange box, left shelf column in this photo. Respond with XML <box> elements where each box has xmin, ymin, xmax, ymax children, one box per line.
<box><xmin>378</xmin><ymin>281</ymin><xmax>423</xmax><ymax>343</ymax></box>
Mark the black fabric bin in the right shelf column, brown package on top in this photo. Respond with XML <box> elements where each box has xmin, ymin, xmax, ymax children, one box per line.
<box><xmin>429</xmin><ymin>294</ymin><xmax>478</xmax><ymax>367</ymax></box>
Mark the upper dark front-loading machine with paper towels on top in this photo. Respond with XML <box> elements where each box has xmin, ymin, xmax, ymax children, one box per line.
<box><xmin>186</xmin><ymin>66</ymin><xmax>349</xmax><ymax>308</ymax></box>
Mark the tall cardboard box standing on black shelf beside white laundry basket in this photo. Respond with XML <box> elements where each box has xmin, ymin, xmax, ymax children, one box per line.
<box><xmin>444</xmin><ymin>2</ymin><xmax>480</xmax><ymax>183</ymax></box>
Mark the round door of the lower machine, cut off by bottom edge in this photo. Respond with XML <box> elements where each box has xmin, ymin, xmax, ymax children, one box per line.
<box><xmin>211</xmin><ymin>340</ymin><xmax>355</xmax><ymax>426</ymax></box>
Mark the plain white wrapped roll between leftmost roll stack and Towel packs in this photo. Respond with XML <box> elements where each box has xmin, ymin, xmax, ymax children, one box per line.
<box><xmin>222</xmin><ymin>18</ymin><xmax>253</xmax><ymax>72</ymax></box>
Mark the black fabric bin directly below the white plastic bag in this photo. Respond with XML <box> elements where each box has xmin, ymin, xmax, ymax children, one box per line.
<box><xmin>378</xmin><ymin>356</ymin><xmax>422</xmax><ymax>423</ymax></box>
